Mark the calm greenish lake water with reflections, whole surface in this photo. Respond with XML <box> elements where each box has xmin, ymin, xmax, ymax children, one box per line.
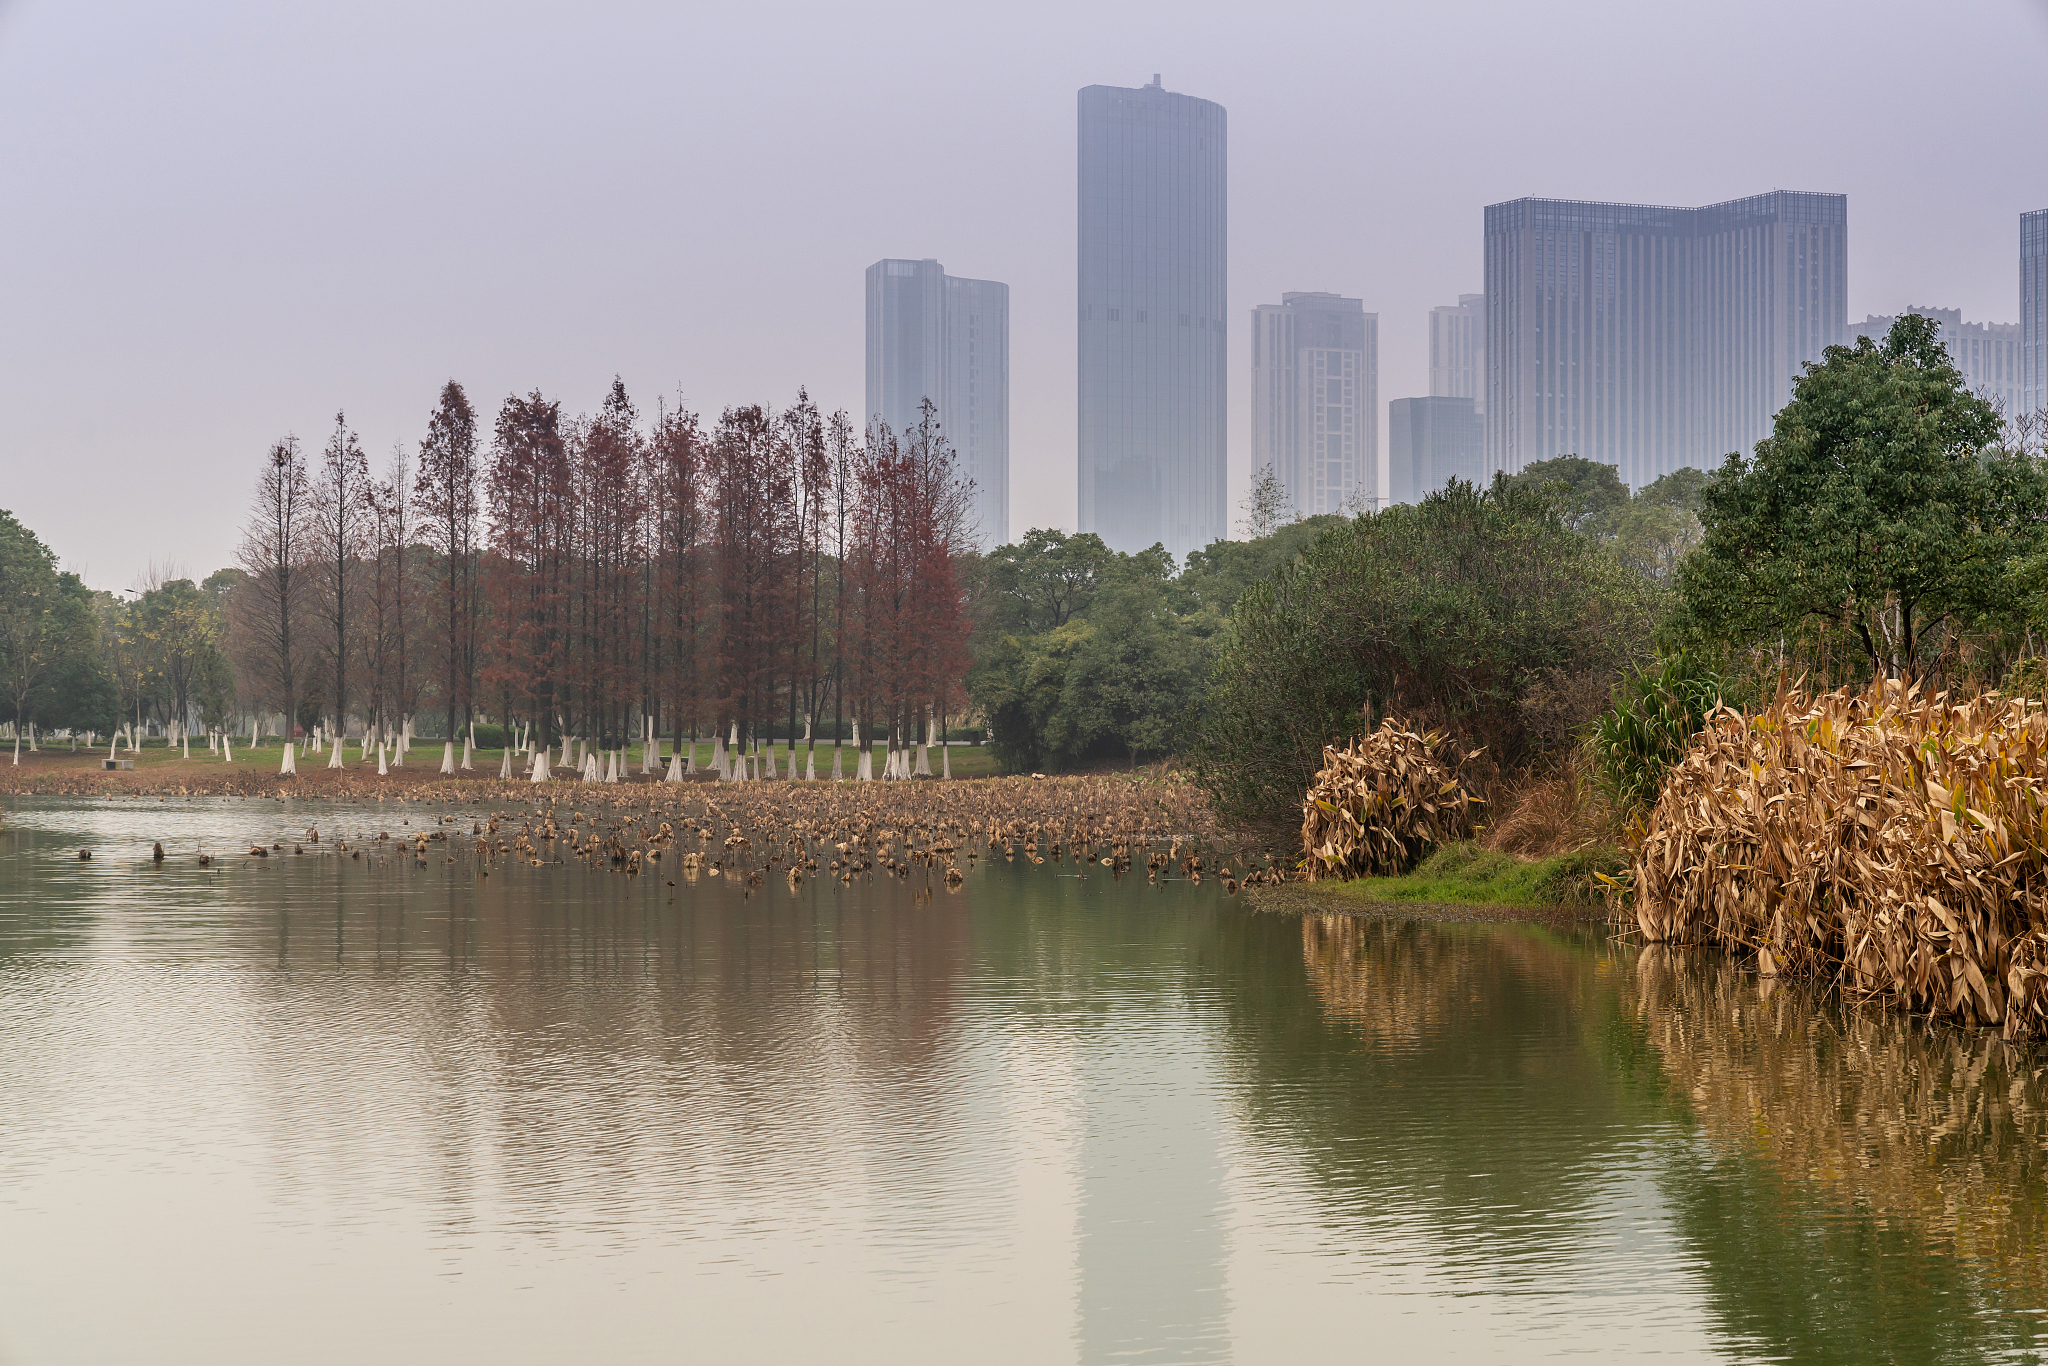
<box><xmin>0</xmin><ymin>799</ymin><xmax>2048</xmax><ymax>1366</ymax></box>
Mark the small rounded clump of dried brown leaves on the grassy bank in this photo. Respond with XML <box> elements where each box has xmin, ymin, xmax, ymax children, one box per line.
<box><xmin>1300</xmin><ymin>717</ymin><xmax>1481</xmax><ymax>883</ymax></box>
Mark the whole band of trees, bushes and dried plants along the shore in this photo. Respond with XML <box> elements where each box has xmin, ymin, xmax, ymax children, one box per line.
<box><xmin>0</xmin><ymin>317</ymin><xmax>2048</xmax><ymax>1038</ymax></box>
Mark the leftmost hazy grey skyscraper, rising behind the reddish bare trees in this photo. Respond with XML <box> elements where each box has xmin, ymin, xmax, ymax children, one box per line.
<box><xmin>866</xmin><ymin>260</ymin><xmax>1010</xmax><ymax>549</ymax></box>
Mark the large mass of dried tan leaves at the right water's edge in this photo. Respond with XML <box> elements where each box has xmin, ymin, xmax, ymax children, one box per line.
<box><xmin>1634</xmin><ymin>682</ymin><xmax>2048</xmax><ymax>1038</ymax></box>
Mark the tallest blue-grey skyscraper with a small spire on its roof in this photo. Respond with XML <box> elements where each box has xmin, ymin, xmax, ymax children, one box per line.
<box><xmin>1077</xmin><ymin>76</ymin><xmax>1229</xmax><ymax>557</ymax></box>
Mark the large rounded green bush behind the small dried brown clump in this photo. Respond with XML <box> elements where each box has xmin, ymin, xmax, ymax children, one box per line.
<box><xmin>1180</xmin><ymin>481</ymin><xmax>1661</xmax><ymax>840</ymax></box>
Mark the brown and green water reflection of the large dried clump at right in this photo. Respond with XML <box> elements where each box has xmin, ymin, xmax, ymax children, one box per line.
<box><xmin>1630</xmin><ymin>948</ymin><xmax>2048</xmax><ymax>1360</ymax></box>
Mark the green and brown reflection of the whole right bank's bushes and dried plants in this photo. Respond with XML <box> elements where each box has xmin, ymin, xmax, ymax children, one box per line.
<box><xmin>1277</xmin><ymin>915</ymin><xmax>2048</xmax><ymax>1360</ymax></box>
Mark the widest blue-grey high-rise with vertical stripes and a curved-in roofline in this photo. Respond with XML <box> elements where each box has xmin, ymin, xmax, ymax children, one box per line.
<box><xmin>1485</xmin><ymin>190</ymin><xmax>1849</xmax><ymax>487</ymax></box>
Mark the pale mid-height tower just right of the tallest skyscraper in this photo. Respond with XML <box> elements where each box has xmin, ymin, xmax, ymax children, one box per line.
<box><xmin>1251</xmin><ymin>293</ymin><xmax>1380</xmax><ymax>516</ymax></box>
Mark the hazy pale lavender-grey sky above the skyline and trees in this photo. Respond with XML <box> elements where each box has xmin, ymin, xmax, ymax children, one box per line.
<box><xmin>0</xmin><ymin>0</ymin><xmax>2048</xmax><ymax>588</ymax></box>
